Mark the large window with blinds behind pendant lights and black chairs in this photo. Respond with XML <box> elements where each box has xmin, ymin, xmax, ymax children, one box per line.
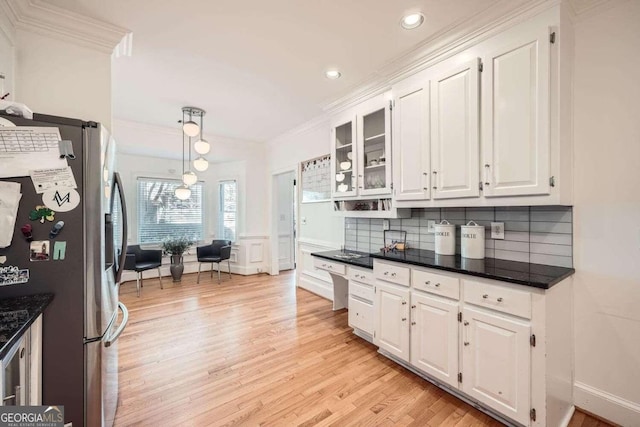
<box><xmin>138</xmin><ymin>178</ymin><xmax>204</xmax><ymax>244</ymax></box>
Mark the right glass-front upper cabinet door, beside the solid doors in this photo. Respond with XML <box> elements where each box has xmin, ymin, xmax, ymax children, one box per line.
<box><xmin>357</xmin><ymin>100</ymin><xmax>391</xmax><ymax>196</ymax></box>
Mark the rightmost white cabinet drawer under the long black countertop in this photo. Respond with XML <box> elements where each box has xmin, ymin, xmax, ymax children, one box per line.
<box><xmin>463</xmin><ymin>280</ymin><xmax>531</xmax><ymax>319</ymax></box>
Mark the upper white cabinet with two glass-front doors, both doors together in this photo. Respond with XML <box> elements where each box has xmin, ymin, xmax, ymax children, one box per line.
<box><xmin>331</xmin><ymin>96</ymin><xmax>391</xmax><ymax>199</ymax></box>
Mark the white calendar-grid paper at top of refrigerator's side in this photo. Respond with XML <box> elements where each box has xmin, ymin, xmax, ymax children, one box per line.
<box><xmin>0</xmin><ymin>126</ymin><xmax>67</xmax><ymax>178</ymax></box>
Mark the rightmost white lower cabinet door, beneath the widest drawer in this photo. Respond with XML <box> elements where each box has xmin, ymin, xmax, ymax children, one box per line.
<box><xmin>462</xmin><ymin>307</ymin><xmax>531</xmax><ymax>425</ymax></box>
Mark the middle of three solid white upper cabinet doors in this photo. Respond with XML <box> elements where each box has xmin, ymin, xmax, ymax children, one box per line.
<box><xmin>431</xmin><ymin>59</ymin><xmax>480</xmax><ymax>199</ymax></box>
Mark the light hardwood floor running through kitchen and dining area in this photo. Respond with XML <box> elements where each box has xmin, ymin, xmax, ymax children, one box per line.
<box><xmin>115</xmin><ymin>273</ymin><xmax>607</xmax><ymax>427</ymax></box>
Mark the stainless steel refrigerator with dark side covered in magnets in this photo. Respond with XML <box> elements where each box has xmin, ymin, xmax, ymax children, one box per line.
<box><xmin>0</xmin><ymin>114</ymin><xmax>128</xmax><ymax>427</ymax></box>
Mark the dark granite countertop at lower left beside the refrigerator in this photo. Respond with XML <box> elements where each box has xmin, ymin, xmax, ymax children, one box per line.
<box><xmin>0</xmin><ymin>294</ymin><xmax>53</xmax><ymax>359</ymax></box>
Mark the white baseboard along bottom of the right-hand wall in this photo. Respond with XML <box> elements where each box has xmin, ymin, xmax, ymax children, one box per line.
<box><xmin>573</xmin><ymin>381</ymin><xmax>640</xmax><ymax>426</ymax></box>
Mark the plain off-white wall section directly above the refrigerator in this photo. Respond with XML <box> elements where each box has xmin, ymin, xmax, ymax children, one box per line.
<box><xmin>13</xmin><ymin>30</ymin><xmax>111</xmax><ymax>128</ymax></box>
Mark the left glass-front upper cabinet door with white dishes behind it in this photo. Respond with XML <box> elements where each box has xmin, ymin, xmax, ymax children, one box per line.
<box><xmin>331</xmin><ymin>116</ymin><xmax>358</xmax><ymax>198</ymax></box>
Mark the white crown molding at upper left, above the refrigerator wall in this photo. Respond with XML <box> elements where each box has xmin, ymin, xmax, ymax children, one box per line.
<box><xmin>0</xmin><ymin>0</ymin><xmax>131</xmax><ymax>54</ymax></box>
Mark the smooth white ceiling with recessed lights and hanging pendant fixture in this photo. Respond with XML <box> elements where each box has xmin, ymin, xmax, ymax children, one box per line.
<box><xmin>49</xmin><ymin>0</ymin><xmax>504</xmax><ymax>141</ymax></box>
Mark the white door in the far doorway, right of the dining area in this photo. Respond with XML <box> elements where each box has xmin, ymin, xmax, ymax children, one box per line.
<box><xmin>273</xmin><ymin>171</ymin><xmax>296</xmax><ymax>271</ymax></box>
